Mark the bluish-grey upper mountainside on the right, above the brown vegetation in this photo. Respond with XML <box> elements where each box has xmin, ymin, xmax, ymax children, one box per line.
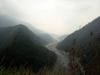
<box><xmin>57</xmin><ymin>17</ymin><xmax>100</xmax><ymax>50</ymax></box>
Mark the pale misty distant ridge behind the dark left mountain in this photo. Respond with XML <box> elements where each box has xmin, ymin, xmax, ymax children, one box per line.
<box><xmin>0</xmin><ymin>15</ymin><xmax>55</xmax><ymax>45</ymax></box>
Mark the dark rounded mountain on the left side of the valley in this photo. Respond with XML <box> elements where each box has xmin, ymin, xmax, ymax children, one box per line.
<box><xmin>0</xmin><ymin>25</ymin><xmax>57</xmax><ymax>71</ymax></box>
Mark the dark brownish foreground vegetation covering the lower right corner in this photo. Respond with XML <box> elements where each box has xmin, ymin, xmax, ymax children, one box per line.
<box><xmin>67</xmin><ymin>38</ymin><xmax>100</xmax><ymax>75</ymax></box>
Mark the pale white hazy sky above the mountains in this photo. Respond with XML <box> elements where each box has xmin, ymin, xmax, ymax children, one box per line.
<box><xmin>0</xmin><ymin>0</ymin><xmax>100</xmax><ymax>35</ymax></box>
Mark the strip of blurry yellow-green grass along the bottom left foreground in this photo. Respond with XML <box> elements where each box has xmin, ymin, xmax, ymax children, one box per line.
<box><xmin>0</xmin><ymin>67</ymin><xmax>66</xmax><ymax>75</ymax></box>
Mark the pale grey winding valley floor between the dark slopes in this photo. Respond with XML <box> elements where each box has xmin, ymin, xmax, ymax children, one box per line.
<box><xmin>46</xmin><ymin>42</ymin><xmax>69</xmax><ymax>72</ymax></box>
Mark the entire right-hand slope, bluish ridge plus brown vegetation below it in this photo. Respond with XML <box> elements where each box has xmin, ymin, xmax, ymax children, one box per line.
<box><xmin>58</xmin><ymin>17</ymin><xmax>100</xmax><ymax>75</ymax></box>
